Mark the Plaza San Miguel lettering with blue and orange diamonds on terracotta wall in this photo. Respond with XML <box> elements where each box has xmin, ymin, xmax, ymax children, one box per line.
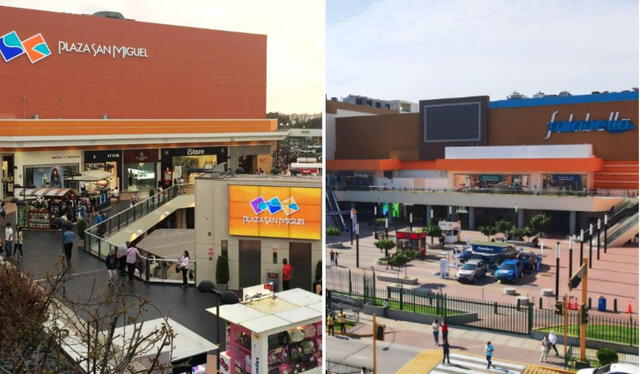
<box><xmin>0</xmin><ymin>31</ymin><xmax>149</xmax><ymax>63</ymax></box>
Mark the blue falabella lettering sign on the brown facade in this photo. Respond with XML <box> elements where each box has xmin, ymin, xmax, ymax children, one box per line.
<box><xmin>544</xmin><ymin>110</ymin><xmax>635</xmax><ymax>140</ymax></box>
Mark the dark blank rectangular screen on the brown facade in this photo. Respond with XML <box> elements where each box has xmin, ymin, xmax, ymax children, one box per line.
<box><xmin>422</xmin><ymin>101</ymin><xmax>482</xmax><ymax>142</ymax></box>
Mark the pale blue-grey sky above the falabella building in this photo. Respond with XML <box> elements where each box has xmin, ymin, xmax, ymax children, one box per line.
<box><xmin>326</xmin><ymin>0</ymin><xmax>639</xmax><ymax>102</ymax></box>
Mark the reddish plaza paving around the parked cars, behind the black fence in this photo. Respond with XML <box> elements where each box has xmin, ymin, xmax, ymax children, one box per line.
<box><xmin>326</xmin><ymin>224</ymin><xmax>638</xmax><ymax>316</ymax></box>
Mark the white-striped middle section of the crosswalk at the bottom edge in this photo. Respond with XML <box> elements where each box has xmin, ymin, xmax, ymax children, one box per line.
<box><xmin>429</xmin><ymin>353</ymin><xmax>525</xmax><ymax>374</ymax></box>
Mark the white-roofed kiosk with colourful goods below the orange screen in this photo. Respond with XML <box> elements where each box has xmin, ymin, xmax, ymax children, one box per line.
<box><xmin>207</xmin><ymin>284</ymin><xmax>323</xmax><ymax>374</ymax></box>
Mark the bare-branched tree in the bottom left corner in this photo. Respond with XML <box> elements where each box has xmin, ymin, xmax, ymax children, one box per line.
<box><xmin>0</xmin><ymin>262</ymin><xmax>175</xmax><ymax>374</ymax></box>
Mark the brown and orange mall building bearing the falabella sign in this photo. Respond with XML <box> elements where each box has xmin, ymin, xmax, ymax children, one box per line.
<box><xmin>327</xmin><ymin>89</ymin><xmax>638</xmax><ymax>234</ymax></box>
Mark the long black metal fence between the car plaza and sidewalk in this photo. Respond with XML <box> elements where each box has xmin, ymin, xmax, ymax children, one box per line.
<box><xmin>327</xmin><ymin>268</ymin><xmax>638</xmax><ymax>346</ymax></box>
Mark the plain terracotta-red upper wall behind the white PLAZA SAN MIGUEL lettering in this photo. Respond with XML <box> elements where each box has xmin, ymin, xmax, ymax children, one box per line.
<box><xmin>0</xmin><ymin>7</ymin><xmax>267</xmax><ymax>119</ymax></box>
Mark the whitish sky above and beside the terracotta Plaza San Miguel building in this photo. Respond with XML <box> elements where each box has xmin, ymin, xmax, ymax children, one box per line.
<box><xmin>0</xmin><ymin>0</ymin><xmax>325</xmax><ymax>113</ymax></box>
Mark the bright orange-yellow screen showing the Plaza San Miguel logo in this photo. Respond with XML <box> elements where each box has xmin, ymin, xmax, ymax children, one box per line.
<box><xmin>229</xmin><ymin>185</ymin><xmax>322</xmax><ymax>240</ymax></box>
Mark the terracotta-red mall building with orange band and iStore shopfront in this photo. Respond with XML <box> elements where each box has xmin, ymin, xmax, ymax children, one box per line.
<box><xmin>0</xmin><ymin>7</ymin><xmax>287</xmax><ymax>197</ymax></box>
